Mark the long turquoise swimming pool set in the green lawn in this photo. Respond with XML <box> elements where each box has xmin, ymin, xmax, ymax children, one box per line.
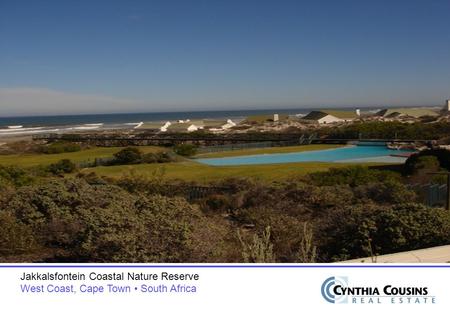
<box><xmin>196</xmin><ymin>145</ymin><xmax>411</xmax><ymax>166</ymax></box>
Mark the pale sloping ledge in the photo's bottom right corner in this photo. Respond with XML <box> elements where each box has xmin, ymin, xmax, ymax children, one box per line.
<box><xmin>340</xmin><ymin>245</ymin><xmax>450</xmax><ymax>263</ymax></box>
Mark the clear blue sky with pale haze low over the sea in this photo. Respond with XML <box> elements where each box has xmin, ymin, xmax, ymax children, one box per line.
<box><xmin>0</xmin><ymin>0</ymin><xmax>450</xmax><ymax>116</ymax></box>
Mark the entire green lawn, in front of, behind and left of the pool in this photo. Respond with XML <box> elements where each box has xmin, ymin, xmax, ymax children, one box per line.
<box><xmin>0</xmin><ymin>145</ymin><xmax>382</xmax><ymax>183</ymax></box>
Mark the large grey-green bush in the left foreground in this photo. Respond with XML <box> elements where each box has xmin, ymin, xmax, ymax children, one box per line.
<box><xmin>6</xmin><ymin>179</ymin><xmax>210</xmax><ymax>262</ymax></box>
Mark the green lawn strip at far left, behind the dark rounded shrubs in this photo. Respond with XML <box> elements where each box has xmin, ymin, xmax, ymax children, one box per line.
<box><xmin>0</xmin><ymin>146</ymin><xmax>167</xmax><ymax>167</ymax></box>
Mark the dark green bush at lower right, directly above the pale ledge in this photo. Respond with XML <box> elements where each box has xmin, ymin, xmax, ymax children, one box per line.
<box><xmin>320</xmin><ymin>203</ymin><xmax>450</xmax><ymax>261</ymax></box>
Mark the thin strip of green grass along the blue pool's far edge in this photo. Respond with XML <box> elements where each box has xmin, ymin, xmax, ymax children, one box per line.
<box><xmin>195</xmin><ymin>144</ymin><xmax>345</xmax><ymax>158</ymax></box>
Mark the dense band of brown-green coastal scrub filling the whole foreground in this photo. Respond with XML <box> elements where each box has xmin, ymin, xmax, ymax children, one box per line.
<box><xmin>0</xmin><ymin>161</ymin><xmax>450</xmax><ymax>262</ymax></box>
